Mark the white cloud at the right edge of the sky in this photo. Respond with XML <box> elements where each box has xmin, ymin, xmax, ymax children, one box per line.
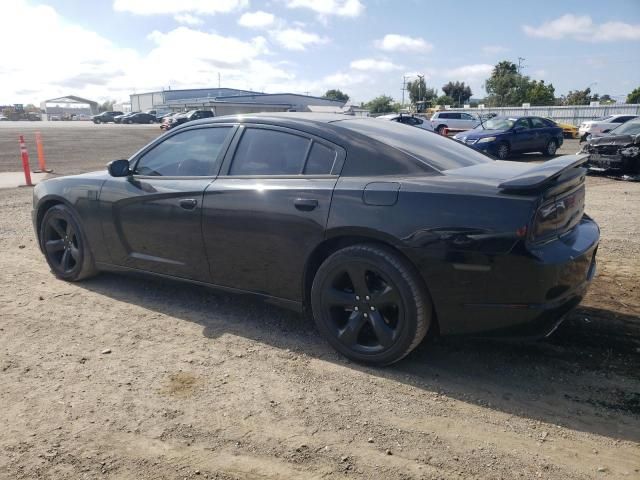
<box><xmin>522</xmin><ymin>14</ymin><xmax>640</xmax><ymax>42</ymax></box>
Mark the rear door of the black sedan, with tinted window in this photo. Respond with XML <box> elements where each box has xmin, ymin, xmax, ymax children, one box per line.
<box><xmin>202</xmin><ymin>125</ymin><xmax>345</xmax><ymax>300</ymax></box>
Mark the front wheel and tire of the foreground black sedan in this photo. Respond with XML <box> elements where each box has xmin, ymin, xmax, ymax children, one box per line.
<box><xmin>40</xmin><ymin>205</ymin><xmax>98</xmax><ymax>282</ymax></box>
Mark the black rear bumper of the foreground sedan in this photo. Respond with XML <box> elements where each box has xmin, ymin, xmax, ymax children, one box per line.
<box><xmin>410</xmin><ymin>215</ymin><xmax>600</xmax><ymax>337</ymax></box>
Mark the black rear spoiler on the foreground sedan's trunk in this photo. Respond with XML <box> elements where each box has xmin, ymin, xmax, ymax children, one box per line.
<box><xmin>498</xmin><ymin>153</ymin><xmax>589</xmax><ymax>193</ymax></box>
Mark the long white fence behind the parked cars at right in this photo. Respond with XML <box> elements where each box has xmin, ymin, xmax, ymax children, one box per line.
<box><xmin>440</xmin><ymin>104</ymin><xmax>640</xmax><ymax>125</ymax></box>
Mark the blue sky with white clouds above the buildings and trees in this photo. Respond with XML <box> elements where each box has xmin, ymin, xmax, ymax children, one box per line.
<box><xmin>0</xmin><ymin>0</ymin><xmax>640</xmax><ymax>104</ymax></box>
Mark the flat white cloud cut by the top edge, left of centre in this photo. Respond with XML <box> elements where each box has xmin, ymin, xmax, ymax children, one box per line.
<box><xmin>113</xmin><ymin>0</ymin><xmax>249</xmax><ymax>15</ymax></box>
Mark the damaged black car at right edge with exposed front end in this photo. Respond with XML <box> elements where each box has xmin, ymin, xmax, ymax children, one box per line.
<box><xmin>582</xmin><ymin>119</ymin><xmax>640</xmax><ymax>181</ymax></box>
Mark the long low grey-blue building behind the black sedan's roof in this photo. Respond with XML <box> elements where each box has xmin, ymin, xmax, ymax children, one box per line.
<box><xmin>130</xmin><ymin>88</ymin><xmax>344</xmax><ymax>116</ymax></box>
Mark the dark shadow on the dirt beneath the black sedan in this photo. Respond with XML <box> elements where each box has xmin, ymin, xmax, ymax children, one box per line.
<box><xmin>80</xmin><ymin>273</ymin><xmax>640</xmax><ymax>442</ymax></box>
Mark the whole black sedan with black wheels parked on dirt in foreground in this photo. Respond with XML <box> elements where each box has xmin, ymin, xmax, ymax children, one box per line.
<box><xmin>33</xmin><ymin>113</ymin><xmax>599</xmax><ymax>365</ymax></box>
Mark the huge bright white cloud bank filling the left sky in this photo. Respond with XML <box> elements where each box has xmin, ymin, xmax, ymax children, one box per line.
<box><xmin>0</xmin><ymin>0</ymin><xmax>297</xmax><ymax>104</ymax></box>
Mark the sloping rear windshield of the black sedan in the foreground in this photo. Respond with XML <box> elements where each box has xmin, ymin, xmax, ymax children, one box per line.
<box><xmin>337</xmin><ymin>119</ymin><xmax>493</xmax><ymax>171</ymax></box>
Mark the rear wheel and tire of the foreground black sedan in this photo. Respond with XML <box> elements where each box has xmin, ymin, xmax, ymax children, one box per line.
<box><xmin>311</xmin><ymin>244</ymin><xmax>433</xmax><ymax>366</ymax></box>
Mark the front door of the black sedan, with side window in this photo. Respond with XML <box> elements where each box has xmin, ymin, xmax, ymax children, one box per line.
<box><xmin>100</xmin><ymin>125</ymin><xmax>236</xmax><ymax>281</ymax></box>
